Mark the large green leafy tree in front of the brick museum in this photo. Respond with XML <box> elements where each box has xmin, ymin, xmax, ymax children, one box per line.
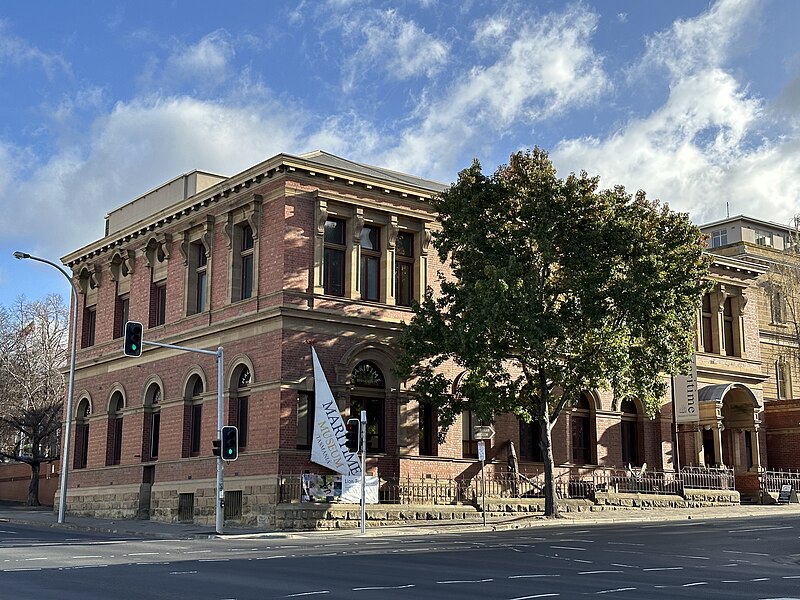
<box><xmin>397</xmin><ymin>148</ymin><xmax>708</xmax><ymax>516</ymax></box>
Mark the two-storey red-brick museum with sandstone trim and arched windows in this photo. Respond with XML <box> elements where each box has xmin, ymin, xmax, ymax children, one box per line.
<box><xmin>56</xmin><ymin>152</ymin><xmax>792</xmax><ymax>522</ymax></box>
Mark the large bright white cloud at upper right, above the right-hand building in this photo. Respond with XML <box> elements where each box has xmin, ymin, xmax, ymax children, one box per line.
<box><xmin>552</xmin><ymin>0</ymin><xmax>800</xmax><ymax>222</ymax></box>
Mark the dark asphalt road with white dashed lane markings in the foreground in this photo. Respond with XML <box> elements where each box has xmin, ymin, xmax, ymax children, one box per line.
<box><xmin>0</xmin><ymin>517</ymin><xmax>800</xmax><ymax>600</ymax></box>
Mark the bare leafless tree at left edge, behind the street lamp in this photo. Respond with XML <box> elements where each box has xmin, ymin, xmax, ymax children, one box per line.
<box><xmin>0</xmin><ymin>294</ymin><xmax>69</xmax><ymax>506</ymax></box>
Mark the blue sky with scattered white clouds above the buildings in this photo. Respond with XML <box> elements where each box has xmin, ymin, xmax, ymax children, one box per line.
<box><xmin>0</xmin><ymin>0</ymin><xmax>800</xmax><ymax>306</ymax></box>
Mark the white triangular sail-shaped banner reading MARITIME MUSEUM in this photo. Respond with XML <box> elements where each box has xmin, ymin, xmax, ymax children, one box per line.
<box><xmin>311</xmin><ymin>346</ymin><xmax>361</xmax><ymax>475</ymax></box>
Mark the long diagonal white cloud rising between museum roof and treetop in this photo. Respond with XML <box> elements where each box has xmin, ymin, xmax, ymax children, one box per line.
<box><xmin>379</xmin><ymin>6</ymin><xmax>610</xmax><ymax>180</ymax></box>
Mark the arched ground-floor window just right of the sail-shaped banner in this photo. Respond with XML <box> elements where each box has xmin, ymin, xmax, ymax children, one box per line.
<box><xmin>350</xmin><ymin>361</ymin><xmax>386</xmax><ymax>452</ymax></box>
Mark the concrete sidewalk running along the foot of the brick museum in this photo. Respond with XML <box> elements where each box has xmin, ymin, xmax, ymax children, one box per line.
<box><xmin>0</xmin><ymin>504</ymin><xmax>800</xmax><ymax>539</ymax></box>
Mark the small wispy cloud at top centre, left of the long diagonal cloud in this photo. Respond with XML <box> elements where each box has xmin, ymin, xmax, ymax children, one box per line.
<box><xmin>343</xmin><ymin>10</ymin><xmax>449</xmax><ymax>91</ymax></box>
